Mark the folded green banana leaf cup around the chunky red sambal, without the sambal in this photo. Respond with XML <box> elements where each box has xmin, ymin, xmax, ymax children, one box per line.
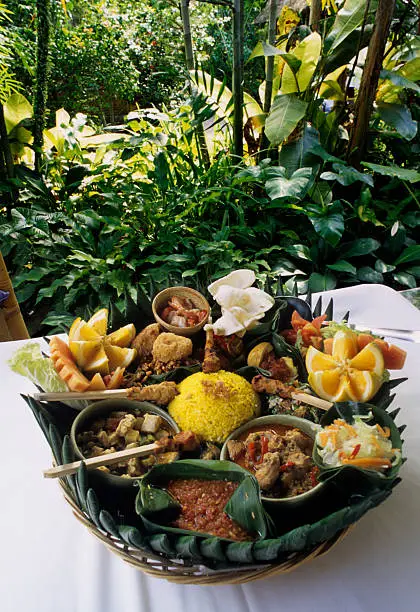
<box><xmin>136</xmin><ymin>459</ymin><xmax>268</xmax><ymax>540</ymax></box>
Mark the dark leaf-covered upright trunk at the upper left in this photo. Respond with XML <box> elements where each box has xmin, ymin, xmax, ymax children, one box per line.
<box><xmin>34</xmin><ymin>0</ymin><xmax>50</xmax><ymax>173</ymax></box>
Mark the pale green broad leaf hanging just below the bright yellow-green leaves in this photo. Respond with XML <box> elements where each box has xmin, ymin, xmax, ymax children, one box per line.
<box><xmin>265</xmin><ymin>94</ymin><xmax>308</xmax><ymax>146</ymax></box>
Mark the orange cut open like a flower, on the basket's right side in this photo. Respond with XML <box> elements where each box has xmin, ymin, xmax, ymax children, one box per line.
<box><xmin>306</xmin><ymin>330</ymin><xmax>385</xmax><ymax>402</ymax></box>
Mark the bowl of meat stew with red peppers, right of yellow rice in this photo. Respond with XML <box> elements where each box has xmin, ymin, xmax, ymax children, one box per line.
<box><xmin>220</xmin><ymin>415</ymin><xmax>323</xmax><ymax>505</ymax></box>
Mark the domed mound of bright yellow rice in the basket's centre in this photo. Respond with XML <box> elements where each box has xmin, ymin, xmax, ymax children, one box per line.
<box><xmin>168</xmin><ymin>370</ymin><xmax>260</xmax><ymax>442</ymax></box>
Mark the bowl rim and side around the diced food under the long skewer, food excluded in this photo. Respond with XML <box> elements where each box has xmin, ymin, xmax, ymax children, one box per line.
<box><xmin>70</xmin><ymin>399</ymin><xmax>180</xmax><ymax>488</ymax></box>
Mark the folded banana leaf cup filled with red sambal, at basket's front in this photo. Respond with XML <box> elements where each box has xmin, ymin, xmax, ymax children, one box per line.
<box><xmin>136</xmin><ymin>459</ymin><xmax>267</xmax><ymax>542</ymax></box>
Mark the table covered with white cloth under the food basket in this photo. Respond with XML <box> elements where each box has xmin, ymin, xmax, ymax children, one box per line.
<box><xmin>0</xmin><ymin>285</ymin><xmax>420</xmax><ymax>612</ymax></box>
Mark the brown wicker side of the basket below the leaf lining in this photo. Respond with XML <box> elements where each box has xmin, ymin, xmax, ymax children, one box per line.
<box><xmin>60</xmin><ymin>478</ymin><xmax>352</xmax><ymax>585</ymax></box>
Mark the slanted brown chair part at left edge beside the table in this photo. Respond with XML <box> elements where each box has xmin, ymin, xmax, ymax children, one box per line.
<box><xmin>0</xmin><ymin>253</ymin><xmax>29</xmax><ymax>342</ymax></box>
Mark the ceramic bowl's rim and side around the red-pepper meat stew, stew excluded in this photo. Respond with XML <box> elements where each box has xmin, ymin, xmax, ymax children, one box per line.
<box><xmin>220</xmin><ymin>414</ymin><xmax>324</xmax><ymax>509</ymax></box>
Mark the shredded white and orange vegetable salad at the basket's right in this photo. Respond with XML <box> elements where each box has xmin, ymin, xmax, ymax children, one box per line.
<box><xmin>316</xmin><ymin>417</ymin><xmax>401</xmax><ymax>471</ymax></box>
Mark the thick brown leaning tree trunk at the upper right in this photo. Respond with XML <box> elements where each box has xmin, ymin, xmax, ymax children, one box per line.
<box><xmin>347</xmin><ymin>0</ymin><xmax>395</xmax><ymax>167</ymax></box>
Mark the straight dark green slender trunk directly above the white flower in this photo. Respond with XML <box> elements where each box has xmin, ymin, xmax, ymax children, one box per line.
<box><xmin>232</xmin><ymin>0</ymin><xmax>244</xmax><ymax>161</ymax></box>
